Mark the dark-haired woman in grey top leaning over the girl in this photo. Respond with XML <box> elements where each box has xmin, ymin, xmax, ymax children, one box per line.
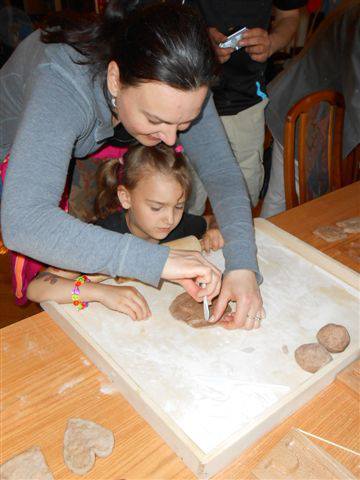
<box><xmin>0</xmin><ymin>1</ymin><xmax>263</xmax><ymax>328</ymax></box>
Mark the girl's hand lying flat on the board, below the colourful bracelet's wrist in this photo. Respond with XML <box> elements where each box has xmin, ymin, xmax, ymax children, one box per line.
<box><xmin>96</xmin><ymin>284</ymin><xmax>151</xmax><ymax>320</ymax></box>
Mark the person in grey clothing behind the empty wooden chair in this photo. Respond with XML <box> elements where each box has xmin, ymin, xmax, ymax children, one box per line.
<box><xmin>261</xmin><ymin>0</ymin><xmax>360</xmax><ymax>217</ymax></box>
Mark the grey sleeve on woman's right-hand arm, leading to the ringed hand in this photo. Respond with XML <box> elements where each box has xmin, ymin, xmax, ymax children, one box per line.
<box><xmin>181</xmin><ymin>97</ymin><xmax>262</xmax><ymax>283</ymax></box>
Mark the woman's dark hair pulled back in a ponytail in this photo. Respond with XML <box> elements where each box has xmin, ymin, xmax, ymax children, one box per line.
<box><xmin>41</xmin><ymin>0</ymin><xmax>217</xmax><ymax>91</ymax></box>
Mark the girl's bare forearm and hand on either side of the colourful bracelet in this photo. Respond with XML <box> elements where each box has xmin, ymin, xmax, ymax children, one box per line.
<box><xmin>27</xmin><ymin>268</ymin><xmax>151</xmax><ymax>320</ymax></box>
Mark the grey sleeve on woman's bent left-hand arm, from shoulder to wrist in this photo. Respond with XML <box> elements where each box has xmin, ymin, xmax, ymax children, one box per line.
<box><xmin>1</xmin><ymin>67</ymin><xmax>169</xmax><ymax>285</ymax></box>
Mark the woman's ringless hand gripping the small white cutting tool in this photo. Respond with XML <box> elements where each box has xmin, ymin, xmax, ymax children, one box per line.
<box><xmin>161</xmin><ymin>249</ymin><xmax>221</xmax><ymax>302</ymax></box>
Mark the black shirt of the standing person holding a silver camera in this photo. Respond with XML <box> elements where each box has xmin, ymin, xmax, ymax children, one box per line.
<box><xmin>189</xmin><ymin>0</ymin><xmax>306</xmax><ymax>115</ymax></box>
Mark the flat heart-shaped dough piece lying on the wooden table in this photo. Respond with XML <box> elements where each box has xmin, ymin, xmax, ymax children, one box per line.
<box><xmin>64</xmin><ymin>418</ymin><xmax>114</xmax><ymax>475</ymax></box>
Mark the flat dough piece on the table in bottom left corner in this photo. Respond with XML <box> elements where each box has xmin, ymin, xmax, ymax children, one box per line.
<box><xmin>0</xmin><ymin>447</ymin><xmax>54</xmax><ymax>480</ymax></box>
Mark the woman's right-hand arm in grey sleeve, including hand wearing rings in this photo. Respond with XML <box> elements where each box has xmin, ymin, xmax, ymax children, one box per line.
<box><xmin>182</xmin><ymin>94</ymin><xmax>264</xmax><ymax>329</ymax></box>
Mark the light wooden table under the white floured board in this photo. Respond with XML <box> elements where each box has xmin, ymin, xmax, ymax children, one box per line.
<box><xmin>0</xmin><ymin>183</ymin><xmax>360</xmax><ymax>480</ymax></box>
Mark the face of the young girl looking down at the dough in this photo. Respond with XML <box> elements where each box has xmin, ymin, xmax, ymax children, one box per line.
<box><xmin>118</xmin><ymin>172</ymin><xmax>185</xmax><ymax>242</ymax></box>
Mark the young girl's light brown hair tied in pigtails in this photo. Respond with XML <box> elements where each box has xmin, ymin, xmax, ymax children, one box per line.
<box><xmin>94</xmin><ymin>144</ymin><xmax>191</xmax><ymax>219</ymax></box>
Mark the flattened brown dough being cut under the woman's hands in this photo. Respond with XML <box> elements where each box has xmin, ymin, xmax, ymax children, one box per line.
<box><xmin>169</xmin><ymin>292</ymin><xmax>231</xmax><ymax>328</ymax></box>
